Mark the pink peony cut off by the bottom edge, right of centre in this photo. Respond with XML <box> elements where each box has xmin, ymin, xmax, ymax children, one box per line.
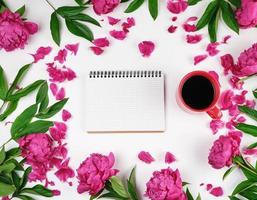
<box><xmin>145</xmin><ymin>168</ymin><xmax>187</xmax><ymax>200</ymax></box>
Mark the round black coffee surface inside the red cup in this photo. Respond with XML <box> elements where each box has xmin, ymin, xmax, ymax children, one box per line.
<box><xmin>182</xmin><ymin>75</ymin><xmax>214</xmax><ymax>110</ymax></box>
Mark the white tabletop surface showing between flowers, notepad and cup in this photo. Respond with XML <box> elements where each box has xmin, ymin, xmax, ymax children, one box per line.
<box><xmin>0</xmin><ymin>0</ymin><xmax>257</xmax><ymax>200</ymax></box>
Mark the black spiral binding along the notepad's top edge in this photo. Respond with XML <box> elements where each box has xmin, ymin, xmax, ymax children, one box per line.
<box><xmin>89</xmin><ymin>71</ymin><xmax>162</xmax><ymax>78</ymax></box>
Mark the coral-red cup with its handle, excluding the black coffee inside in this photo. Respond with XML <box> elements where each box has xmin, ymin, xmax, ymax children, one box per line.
<box><xmin>177</xmin><ymin>71</ymin><xmax>222</xmax><ymax>119</ymax></box>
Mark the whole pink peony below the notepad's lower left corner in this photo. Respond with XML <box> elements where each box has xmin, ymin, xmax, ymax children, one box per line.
<box><xmin>77</xmin><ymin>153</ymin><xmax>118</xmax><ymax>195</ymax></box>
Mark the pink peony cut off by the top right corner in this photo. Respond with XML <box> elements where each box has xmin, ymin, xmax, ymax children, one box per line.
<box><xmin>236</xmin><ymin>0</ymin><xmax>257</xmax><ymax>28</ymax></box>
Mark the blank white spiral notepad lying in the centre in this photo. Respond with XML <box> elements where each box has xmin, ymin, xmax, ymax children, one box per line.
<box><xmin>85</xmin><ymin>71</ymin><xmax>165</xmax><ymax>132</ymax></box>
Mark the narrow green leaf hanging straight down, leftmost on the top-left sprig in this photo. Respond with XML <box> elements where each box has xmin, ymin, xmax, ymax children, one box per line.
<box><xmin>50</xmin><ymin>12</ymin><xmax>61</xmax><ymax>46</ymax></box>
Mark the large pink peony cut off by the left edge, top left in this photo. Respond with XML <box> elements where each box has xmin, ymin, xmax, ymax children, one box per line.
<box><xmin>0</xmin><ymin>9</ymin><xmax>38</xmax><ymax>51</ymax></box>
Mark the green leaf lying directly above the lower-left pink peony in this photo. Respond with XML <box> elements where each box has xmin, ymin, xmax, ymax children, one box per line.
<box><xmin>13</xmin><ymin>120</ymin><xmax>53</xmax><ymax>140</ymax></box>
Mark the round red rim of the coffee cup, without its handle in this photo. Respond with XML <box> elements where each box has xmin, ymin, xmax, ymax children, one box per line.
<box><xmin>178</xmin><ymin>70</ymin><xmax>220</xmax><ymax>112</ymax></box>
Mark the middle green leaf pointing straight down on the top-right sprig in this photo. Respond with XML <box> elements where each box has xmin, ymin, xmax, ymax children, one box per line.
<box><xmin>208</xmin><ymin>9</ymin><xmax>220</xmax><ymax>42</ymax></box>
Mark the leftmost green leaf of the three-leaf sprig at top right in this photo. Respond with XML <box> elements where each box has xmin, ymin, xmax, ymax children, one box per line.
<box><xmin>196</xmin><ymin>0</ymin><xmax>218</xmax><ymax>30</ymax></box>
